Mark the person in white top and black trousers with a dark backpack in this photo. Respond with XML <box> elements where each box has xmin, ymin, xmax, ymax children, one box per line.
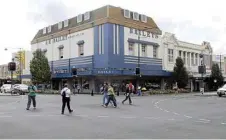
<box><xmin>61</xmin><ymin>84</ymin><xmax>73</xmax><ymax>114</ymax></box>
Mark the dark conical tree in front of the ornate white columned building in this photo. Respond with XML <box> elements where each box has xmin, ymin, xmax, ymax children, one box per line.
<box><xmin>173</xmin><ymin>57</ymin><xmax>188</xmax><ymax>88</ymax></box>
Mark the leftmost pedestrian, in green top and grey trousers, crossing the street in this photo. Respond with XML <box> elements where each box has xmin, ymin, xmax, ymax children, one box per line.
<box><xmin>26</xmin><ymin>83</ymin><xmax>37</xmax><ymax>110</ymax></box>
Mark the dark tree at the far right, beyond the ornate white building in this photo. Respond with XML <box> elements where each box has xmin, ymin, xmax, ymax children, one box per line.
<box><xmin>209</xmin><ymin>63</ymin><xmax>224</xmax><ymax>90</ymax></box>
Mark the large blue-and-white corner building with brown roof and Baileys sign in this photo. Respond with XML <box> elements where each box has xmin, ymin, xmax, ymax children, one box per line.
<box><xmin>23</xmin><ymin>5</ymin><xmax>170</xmax><ymax>91</ymax></box>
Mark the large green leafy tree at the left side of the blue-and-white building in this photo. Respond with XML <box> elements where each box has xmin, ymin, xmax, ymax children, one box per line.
<box><xmin>30</xmin><ymin>49</ymin><xmax>51</xmax><ymax>84</ymax></box>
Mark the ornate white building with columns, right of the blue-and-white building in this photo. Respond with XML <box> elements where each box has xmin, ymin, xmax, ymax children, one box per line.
<box><xmin>162</xmin><ymin>32</ymin><xmax>212</xmax><ymax>91</ymax></box>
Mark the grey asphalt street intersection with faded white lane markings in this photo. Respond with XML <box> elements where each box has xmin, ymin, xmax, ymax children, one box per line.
<box><xmin>0</xmin><ymin>94</ymin><xmax>226</xmax><ymax>139</ymax></box>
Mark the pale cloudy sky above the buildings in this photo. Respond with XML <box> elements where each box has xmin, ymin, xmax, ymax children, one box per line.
<box><xmin>0</xmin><ymin>0</ymin><xmax>226</xmax><ymax>64</ymax></box>
